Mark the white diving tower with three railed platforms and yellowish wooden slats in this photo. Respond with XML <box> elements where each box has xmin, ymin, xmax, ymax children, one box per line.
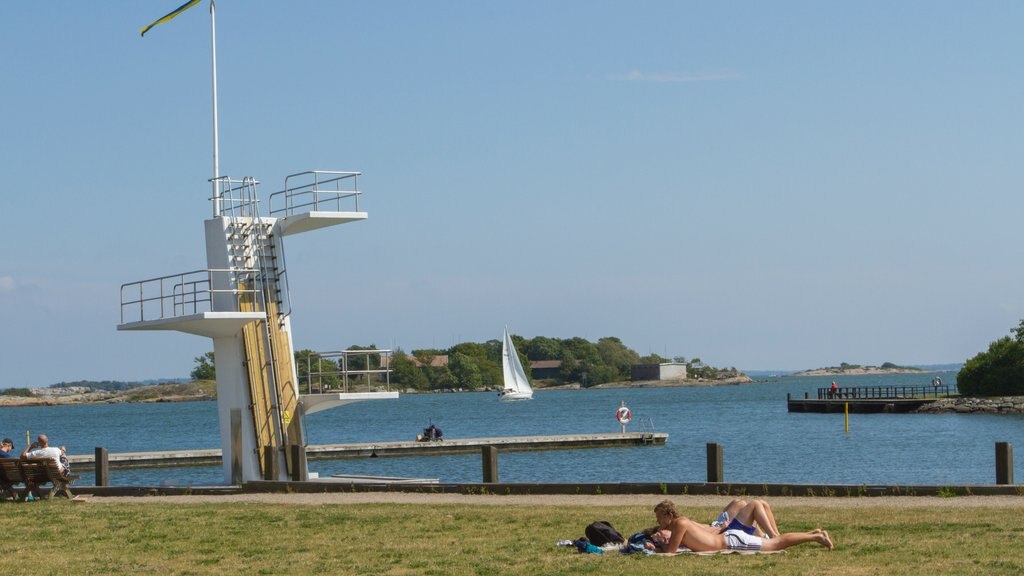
<box><xmin>118</xmin><ymin>170</ymin><xmax>398</xmax><ymax>484</ymax></box>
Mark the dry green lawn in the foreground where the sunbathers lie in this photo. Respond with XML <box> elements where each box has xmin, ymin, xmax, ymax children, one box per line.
<box><xmin>0</xmin><ymin>497</ymin><xmax>1024</xmax><ymax>576</ymax></box>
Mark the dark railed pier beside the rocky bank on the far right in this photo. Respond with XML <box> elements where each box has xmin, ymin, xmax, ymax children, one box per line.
<box><xmin>785</xmin><ymin>384</ymin><xmax>950</xmax><ymax>414</ymax></box>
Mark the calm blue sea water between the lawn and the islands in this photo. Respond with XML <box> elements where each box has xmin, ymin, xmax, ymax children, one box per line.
<box><xmin>0</xmin><ymin>373</ymin><xmax>1024</xmax><ymax>485</ymax></box>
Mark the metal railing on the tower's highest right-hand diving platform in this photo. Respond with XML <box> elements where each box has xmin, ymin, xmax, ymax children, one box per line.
<box><xmin>270</xmin><ymin>170</ymin><xmax>362</xmax><ymax>217</ymax></box>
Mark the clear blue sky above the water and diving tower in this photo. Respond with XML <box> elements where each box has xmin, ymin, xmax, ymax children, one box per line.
<box><xmin>0</xmin><ymin>0</ymin><xmax>1024</xmax><ymax>386</ymax></box>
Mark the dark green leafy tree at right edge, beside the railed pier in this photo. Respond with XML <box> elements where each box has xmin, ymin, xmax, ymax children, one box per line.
<box><xmin>956</xmin><ymin>332</ymin><xmax>1024</xmax><ymax>396</ymax></box>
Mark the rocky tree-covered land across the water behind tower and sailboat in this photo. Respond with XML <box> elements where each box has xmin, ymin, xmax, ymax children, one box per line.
<box><xmin>0</xmin><ymin>335</ymin><xmax>753</xmax><ymax>406</ymax></box>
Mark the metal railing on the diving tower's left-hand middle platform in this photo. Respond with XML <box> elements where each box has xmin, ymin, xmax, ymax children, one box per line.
<box><xmin>121</xmin><ymin>269</ymin><xmax>259</xmax><ymax>324</ymax></box>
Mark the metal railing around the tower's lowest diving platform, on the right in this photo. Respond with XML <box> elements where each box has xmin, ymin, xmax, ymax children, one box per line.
<box><xmin>299</xmin><ymin>349</ymin><xmax>392</xmax><ymax>394</ymax></box>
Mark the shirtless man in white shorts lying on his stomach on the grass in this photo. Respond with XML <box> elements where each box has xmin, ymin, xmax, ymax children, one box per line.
<box><xmin>646</xmin><ymin>500</ymin><xmax>834</xmax><ymax>552</ymax></box>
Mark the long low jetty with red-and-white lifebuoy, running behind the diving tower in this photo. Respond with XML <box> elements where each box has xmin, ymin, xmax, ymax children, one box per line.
<box><xmin>68</xmin><ymin>433</ymin><xmax>669</xmax><ymax>468</ymax></box>
